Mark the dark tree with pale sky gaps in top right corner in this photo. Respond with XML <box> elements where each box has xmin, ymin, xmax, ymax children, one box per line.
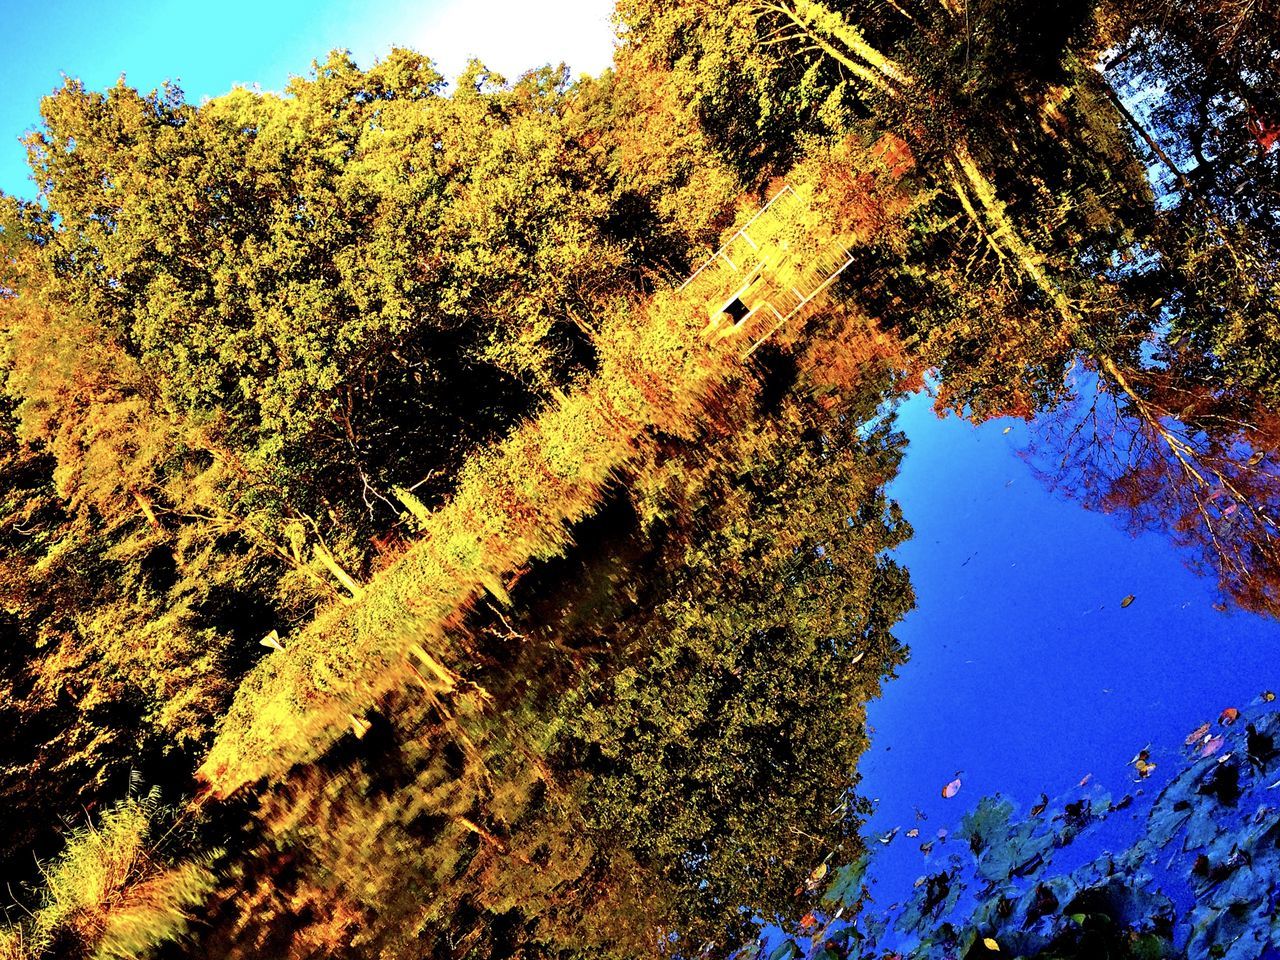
<box><xmin>1103</xmin><ymin>0</ymin><xmax>1280</xmax><ymax>404</ymax></box>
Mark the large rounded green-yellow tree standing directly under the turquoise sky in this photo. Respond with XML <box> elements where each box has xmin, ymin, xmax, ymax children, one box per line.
<box><xmin>10</xmin><ymin>50</ymin><xmax>645</xmax><ymax>572</ymax></box>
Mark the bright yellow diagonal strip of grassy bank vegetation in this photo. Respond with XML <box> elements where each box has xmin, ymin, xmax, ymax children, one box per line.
<box><xmin>200</xmin><ymin>171</ymin><xmax>901</xmax><ymax>796</ymax></box>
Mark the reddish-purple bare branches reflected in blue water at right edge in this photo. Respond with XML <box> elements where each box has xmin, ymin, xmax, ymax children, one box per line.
<box><xmin>1028</xmin><ymin>340</ymin><xmax>1280</xmax><ymax>616</ymax></box>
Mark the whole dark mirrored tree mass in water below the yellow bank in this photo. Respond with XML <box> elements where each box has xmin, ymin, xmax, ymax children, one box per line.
<box><xmin>186</xmin><ymin>348</ymin><xmax>913</xmax><ymax>957</ymax></box>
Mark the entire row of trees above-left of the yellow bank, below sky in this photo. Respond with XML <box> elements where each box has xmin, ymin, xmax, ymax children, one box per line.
<box><xmin>4</xmin><ymin>45</ymin><xmax>747</xmax><ymax>880</ymax></box>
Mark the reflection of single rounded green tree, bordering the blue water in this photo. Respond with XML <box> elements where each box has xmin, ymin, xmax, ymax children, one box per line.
<box><xmin>566</xmin><ymin>386</ymin><xmax>913</xmax><ymax>943</ymax></box>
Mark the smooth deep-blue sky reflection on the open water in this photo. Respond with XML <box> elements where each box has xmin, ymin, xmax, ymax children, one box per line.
<box><xmin>859</xmin><ymin>394</ymin><xmax>1280</xmax><ymax>908</ymax></box>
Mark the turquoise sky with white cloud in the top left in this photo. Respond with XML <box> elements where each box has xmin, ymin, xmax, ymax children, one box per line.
<box><xmin>0</xmin><ymin>0</ymin><xmax>613</xmax><ymax>197</ymax></box>
